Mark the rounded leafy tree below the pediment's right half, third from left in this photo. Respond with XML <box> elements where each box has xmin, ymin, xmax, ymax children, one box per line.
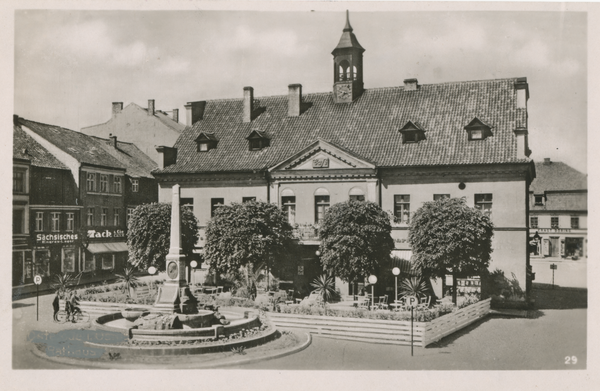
<box><xmin>319</xmin><ymin>201</ymin><xmax>394</xmax><ymax>290</ymax></box>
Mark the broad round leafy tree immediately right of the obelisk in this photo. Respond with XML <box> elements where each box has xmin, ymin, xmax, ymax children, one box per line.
<box><xmin>204</xmin><ymin>201</ymin><xmax>293</xmax><ymax>275</ymax></box>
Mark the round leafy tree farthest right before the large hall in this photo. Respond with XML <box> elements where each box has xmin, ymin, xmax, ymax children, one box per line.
<box><xmin>408</xmin><ymin>198</ymin><xmax>494</xmax><ymax>303</ymax></box>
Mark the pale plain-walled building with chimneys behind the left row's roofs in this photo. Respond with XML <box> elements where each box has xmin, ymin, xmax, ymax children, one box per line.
<box><xmin>81</xmin><ymin>99</ymin><xmax>185</xmax><ymax>162</ymax></box>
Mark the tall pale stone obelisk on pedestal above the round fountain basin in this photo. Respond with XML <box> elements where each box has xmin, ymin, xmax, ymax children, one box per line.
<box><xmin>154</xmin><ymin>185</ymin><xmax>198</xmax><ymax>314</ymax></box>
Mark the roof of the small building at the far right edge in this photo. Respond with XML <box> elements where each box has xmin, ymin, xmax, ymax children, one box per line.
<box><xmin>529</xmin><ymin>162</ymin><xmax>587</xmax><ymax>194</ymax></box>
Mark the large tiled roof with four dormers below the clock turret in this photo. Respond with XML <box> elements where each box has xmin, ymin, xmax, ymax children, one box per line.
<box><xmin>157</xmin><ymin>79</ymin><xmax>530</xmax><ymax>173</ymax></box>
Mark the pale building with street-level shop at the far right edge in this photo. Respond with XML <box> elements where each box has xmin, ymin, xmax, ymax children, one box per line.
<box><xmin>529</xmin><ymin>158</ymin><xmax>587</xmax><ymax>259</ymax></box>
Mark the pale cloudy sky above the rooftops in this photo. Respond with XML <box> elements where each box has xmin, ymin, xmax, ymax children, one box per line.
<box><xmin>14</xmin><ymin>3</ymin><xmax>588</xmax><ymax>173</ymax></box>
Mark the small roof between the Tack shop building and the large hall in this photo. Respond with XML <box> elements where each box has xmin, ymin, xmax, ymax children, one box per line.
<box><xmin>92</xmin><ymin>136</ymin><xmax>158</xmax><ymax>178</ymax></box>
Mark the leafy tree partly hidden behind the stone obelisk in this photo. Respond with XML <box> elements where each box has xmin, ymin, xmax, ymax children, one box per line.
<box><xmin>127</xmin><ymin>203</ymin><xmax>198</xmax><ymax>271</ymax></box>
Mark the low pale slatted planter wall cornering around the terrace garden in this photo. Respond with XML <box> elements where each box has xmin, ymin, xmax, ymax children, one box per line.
<box><xmin>268</xmin><ymin>299</ymin><xmax>491</xmax><ymax>347</ymax></box>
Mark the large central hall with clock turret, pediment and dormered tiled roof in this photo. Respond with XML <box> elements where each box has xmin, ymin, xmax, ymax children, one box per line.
<box><xmin>154</xmin><ymin>14</ymin><xmax>535</xmax><ymax>293</ymax></box>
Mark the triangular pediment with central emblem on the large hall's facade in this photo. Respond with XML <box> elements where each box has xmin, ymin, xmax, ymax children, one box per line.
<box><xmin>269</xmin><ymin>139</ymin><xmax>375</xmax><ymax>171</ymax></box>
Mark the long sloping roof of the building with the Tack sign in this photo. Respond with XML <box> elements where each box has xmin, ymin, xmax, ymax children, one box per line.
<box><xmin>18</xmin><ymin>118</ymin><xmax>125</xmax><ymax>168</ymax></box>
